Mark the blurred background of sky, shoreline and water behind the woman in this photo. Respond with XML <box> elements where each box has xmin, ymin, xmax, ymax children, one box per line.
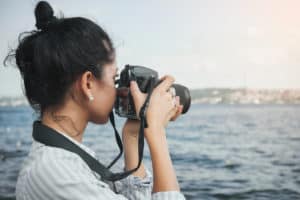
<box><xmin>0</xmin><ymin>0</ymin><xmax>300</xmax><ymax>200</ymax></box>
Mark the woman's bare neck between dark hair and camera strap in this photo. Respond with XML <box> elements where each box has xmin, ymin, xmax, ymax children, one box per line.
<box><xmin>42</xmin><ymin>103</ymin><xmax>88</xmax><ymax>142</ymax></box>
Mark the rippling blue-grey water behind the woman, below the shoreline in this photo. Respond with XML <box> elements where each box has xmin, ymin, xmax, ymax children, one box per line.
<box><xmin>0</xmin><ymin>104</ymin><xmax>300</xmax><ymax>200</ymax></box>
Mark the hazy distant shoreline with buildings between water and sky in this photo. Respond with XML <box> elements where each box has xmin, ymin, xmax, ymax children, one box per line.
<box><xmin>0</xmin><ymin>88</ymin><xmax>300</xmax><ymax>107</ymax></box>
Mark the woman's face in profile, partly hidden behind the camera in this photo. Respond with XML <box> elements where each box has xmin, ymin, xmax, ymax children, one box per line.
<box><xmin>88</xmin><ymin>63</ymin><xmax>118</xmax><ymax>124</ymax></box>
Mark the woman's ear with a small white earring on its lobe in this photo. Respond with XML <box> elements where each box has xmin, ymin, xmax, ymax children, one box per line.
<box><xmin>79</xmin><ymin>71</ymin><xmax>96</xmax><ymax>101</ymax></box>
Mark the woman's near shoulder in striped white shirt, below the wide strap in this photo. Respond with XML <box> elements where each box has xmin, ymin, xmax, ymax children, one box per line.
<box><xmin>17</xmin><ymin>141</ymin><xmax>123</xmax><ymax>199</ymax></box>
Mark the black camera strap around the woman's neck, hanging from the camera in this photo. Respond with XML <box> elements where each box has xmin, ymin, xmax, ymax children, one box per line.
<box><xmin>32</xmin><ymin>81</ymin><xmax>154</xmax><ymax>182</ymax></box>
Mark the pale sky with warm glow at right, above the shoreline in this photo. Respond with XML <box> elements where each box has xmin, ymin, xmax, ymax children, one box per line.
<box><xmin>0</xmin><ymin>0</ymin><xmax>300</xmax><ymax>97</ymax></box>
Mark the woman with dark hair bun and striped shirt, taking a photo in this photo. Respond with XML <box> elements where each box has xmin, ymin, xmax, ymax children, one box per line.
<box><xmin>8</xmin><ymin>2</ymin><xmax>184</xmax><ymax>200</ymax></box>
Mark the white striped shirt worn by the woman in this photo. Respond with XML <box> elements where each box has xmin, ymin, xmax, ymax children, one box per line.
<box><xmin>16</xmin><ymin>132</ymin><xmax>185</xmax><ymax>200</ymax></box>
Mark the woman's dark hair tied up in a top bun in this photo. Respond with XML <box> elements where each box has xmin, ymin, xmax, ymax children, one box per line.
<box><xmin>4</xmin><ymin>1</ymin><xmax>115</xmax><ymax>115</ymax></box>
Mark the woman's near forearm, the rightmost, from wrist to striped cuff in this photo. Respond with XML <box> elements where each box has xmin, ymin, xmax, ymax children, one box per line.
<box><xmin>147</xmin><ymin>129</ymin><xmax>180</xmax><ymax>193</ymax></box>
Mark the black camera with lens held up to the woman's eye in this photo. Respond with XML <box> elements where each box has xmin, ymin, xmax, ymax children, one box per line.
<box><xmin>114</xmin><ymin>65</ymin><xmax>191</xmax><ymax>119</ymax></box>
